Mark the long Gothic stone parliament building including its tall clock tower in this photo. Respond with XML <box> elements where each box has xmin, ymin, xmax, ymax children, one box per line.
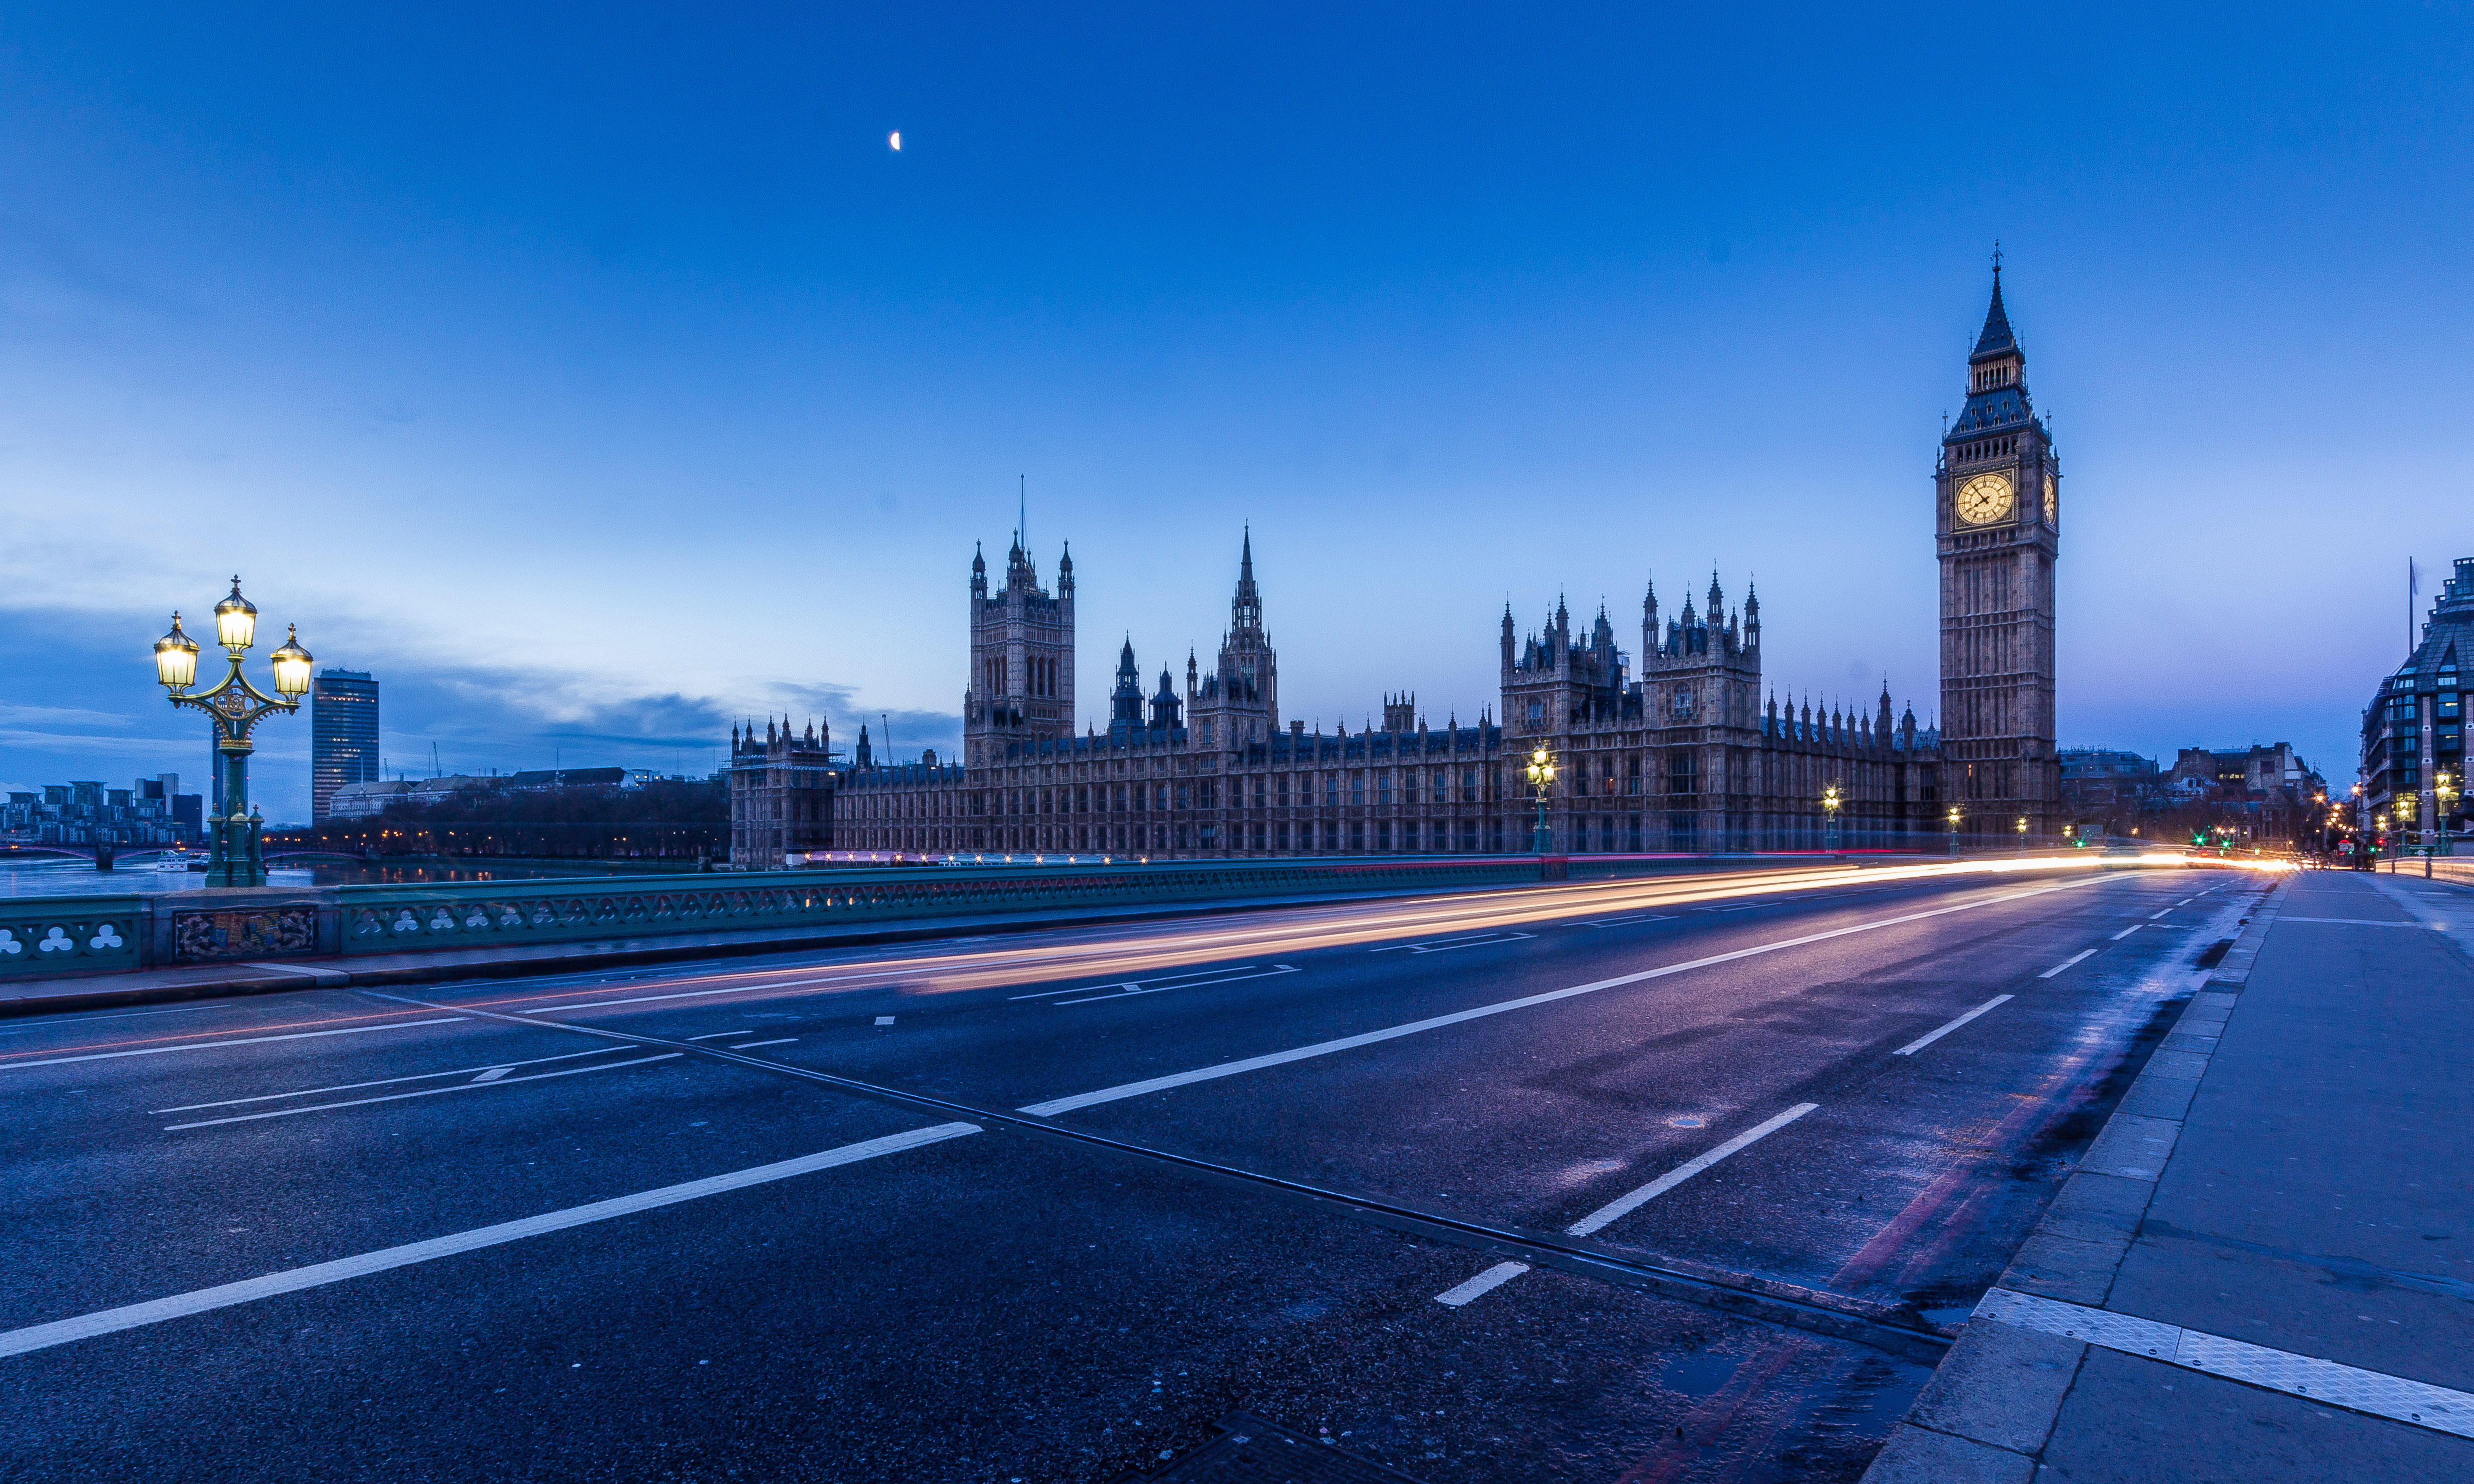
<box><xmin>730</xmin><ymin>265</ymin><xmax>2061</xmax><ymax>868</ymax></box>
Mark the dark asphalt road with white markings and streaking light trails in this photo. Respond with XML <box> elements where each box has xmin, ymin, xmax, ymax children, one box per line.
<box><xmin>0</xmin><ymin>868</ymin><xmax>2261</xmax><ymax>1484</ymax></box>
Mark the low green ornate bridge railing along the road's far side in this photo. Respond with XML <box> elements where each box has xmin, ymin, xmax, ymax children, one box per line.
<box><xmin>0</xmin><ymin>856</ymin><xmax>1919</xmax><ymax>980</ymax></box>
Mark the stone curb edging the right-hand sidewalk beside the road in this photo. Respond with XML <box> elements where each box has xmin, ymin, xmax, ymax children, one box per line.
<box><xmin>1863</xmin><ymin>881</ymin><xmax>2291</xmax><ymax>1484</ymax></box>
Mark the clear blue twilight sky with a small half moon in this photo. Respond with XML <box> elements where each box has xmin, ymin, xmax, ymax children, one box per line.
<box><xmin>0</xmin><ymin>5</ymin><xmax>2474</xmax><ymax>821</ymax></box>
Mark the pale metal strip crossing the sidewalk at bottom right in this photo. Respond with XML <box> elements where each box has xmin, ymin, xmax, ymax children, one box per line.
<box><xmin>1972</xmin><ymin>1289</ymin><xmax>2474</xmax><ymax>1437</ymax></box>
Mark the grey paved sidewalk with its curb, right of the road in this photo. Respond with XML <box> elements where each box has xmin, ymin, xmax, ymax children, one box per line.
<box><xmin>1865</xmin><ymin>871</ymin><xmax>2474</xmax><ymax>1484</ymax></box>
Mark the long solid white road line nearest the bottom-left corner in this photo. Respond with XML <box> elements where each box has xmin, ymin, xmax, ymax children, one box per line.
<box><xmin>0</xmin><ymin>1123</ymin><xmax>980</xmax><ymax>1358</ymax></box>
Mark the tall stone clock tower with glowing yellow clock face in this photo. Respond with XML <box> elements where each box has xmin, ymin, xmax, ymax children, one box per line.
<box><xmin>1932</xmin><ymin>252</ymin><xmax>2061</xmax><ymax>839</ymax></box>
